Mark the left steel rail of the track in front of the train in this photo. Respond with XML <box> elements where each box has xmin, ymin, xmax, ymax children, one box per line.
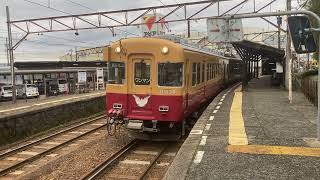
<box><xmin>81</xmin><ymin>139</ymin><xmax>139</xmax><ymax>180</ymax></box>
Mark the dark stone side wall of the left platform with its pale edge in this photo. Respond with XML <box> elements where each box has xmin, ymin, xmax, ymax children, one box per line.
<box><xmin>0</xmin><ymin>93</ymin><xmax>105</xmax><ymax>145</ymax></box>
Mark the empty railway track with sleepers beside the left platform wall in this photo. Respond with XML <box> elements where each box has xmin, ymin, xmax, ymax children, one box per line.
<box><xmin>0</xmin><ymin>115</ymin><xmax>106</xmax><ymax>177</ymax></box>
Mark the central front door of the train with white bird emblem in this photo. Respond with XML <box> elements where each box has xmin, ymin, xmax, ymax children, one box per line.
<box><xmin>128</xmin><ymin>56</ymin><xmax>154</xmax><ymax>115</ymax></box>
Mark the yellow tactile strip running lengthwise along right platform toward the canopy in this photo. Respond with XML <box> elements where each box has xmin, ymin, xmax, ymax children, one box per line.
<box><xmin>229</xmin><ymin>86</ymin><xmax>248</xmax><ymax>145</ymax></box>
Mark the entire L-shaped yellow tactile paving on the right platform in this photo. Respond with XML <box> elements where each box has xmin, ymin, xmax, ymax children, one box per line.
<box><xmin>226</xmin><ymin>86</ymin><xmax>320</xmax><ymax>157</ymax></box>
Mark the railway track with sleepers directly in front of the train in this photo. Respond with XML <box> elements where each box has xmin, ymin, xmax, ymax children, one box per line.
<box><xmin>82</xmin><ymin>140</ymin><xmax>169</xmax><ymax>180</ymax></box>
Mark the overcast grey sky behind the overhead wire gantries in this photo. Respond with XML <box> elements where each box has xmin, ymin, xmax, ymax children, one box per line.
<box><xmin>0</xmin><ymin>0</ymin><xmax>292</xmax><ymax>63</ymax></box>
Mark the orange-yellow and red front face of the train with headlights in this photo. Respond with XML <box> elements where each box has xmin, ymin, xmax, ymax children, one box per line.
<box><xmin>104</xmin><ymin>38</ymin><xmax>187</xmax><ymax>140</ymax></box>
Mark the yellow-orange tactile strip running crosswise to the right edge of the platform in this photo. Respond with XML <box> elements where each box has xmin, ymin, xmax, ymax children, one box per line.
<box><xmin>227</xmin><ymin>145</ymin><xmax>320</xmax><ymax>157</ymax></box>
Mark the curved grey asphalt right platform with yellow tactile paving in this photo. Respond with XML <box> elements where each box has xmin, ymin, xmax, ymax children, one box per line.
<box><xmin>164</xmin><ymin>76</ymin><xmax>320</xmax><ymax>179</ymax></box>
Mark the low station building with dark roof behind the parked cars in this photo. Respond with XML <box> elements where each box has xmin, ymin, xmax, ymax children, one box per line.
<box><xmin>0</xmin><ymin>47</ymin><xmax>107</xmax><ymax>94</ymax></box>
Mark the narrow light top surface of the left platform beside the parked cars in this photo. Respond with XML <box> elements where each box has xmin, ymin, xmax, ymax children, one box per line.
<box><xmin>0</xmin><ymin>90</ymin><xmax>106</xmax><ymax>118</ymax></box>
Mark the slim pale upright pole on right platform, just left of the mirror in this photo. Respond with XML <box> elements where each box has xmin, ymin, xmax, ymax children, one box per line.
<box><xmin>286</xmin><ymin>0</ymin><xmax>292</xmax><ymax>103</ymax></box>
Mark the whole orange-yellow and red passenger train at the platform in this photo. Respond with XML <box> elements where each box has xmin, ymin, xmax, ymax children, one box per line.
<box><xmin>103</xmin><ymin>37</ymin><xmax>240</xmax><ymax>140</ymax></box>
